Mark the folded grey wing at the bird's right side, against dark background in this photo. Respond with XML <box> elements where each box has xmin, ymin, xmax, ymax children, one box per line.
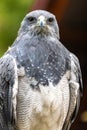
<box><xmin>63</xmin><ymin>53</ymin><xmax>83</xmax><ymax>130</ymax></box>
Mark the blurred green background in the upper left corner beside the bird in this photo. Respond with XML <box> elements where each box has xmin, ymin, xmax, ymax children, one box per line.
<box><xmin>0</xmin><ymin>0</ymin><xmax>33</xmax><ymax>56</ymax></box>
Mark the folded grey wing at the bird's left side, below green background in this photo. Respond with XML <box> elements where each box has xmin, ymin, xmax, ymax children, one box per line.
<box><xmin>0</xmin><ymin>54</ymin><xmax>18</xmax><ymax>130</ymax></box>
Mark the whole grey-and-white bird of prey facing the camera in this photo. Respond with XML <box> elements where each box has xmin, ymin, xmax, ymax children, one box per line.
<box><xmin>0</xmin><ymin>10</ymin><xmax>82</xmax><ymax>130</ymax></box>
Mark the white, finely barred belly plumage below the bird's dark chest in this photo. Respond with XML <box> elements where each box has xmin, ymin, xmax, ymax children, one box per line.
<box><xmin>17</xmin><ymin>72</ymin><xmax>69</xmax><ymax>130</ymax></box>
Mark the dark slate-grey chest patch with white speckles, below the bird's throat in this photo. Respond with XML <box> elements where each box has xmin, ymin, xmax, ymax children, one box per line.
<box><xmin>9</xmin><ymin>39</ymin><xmax>69</xmax><ymax>85</ymax></box>
